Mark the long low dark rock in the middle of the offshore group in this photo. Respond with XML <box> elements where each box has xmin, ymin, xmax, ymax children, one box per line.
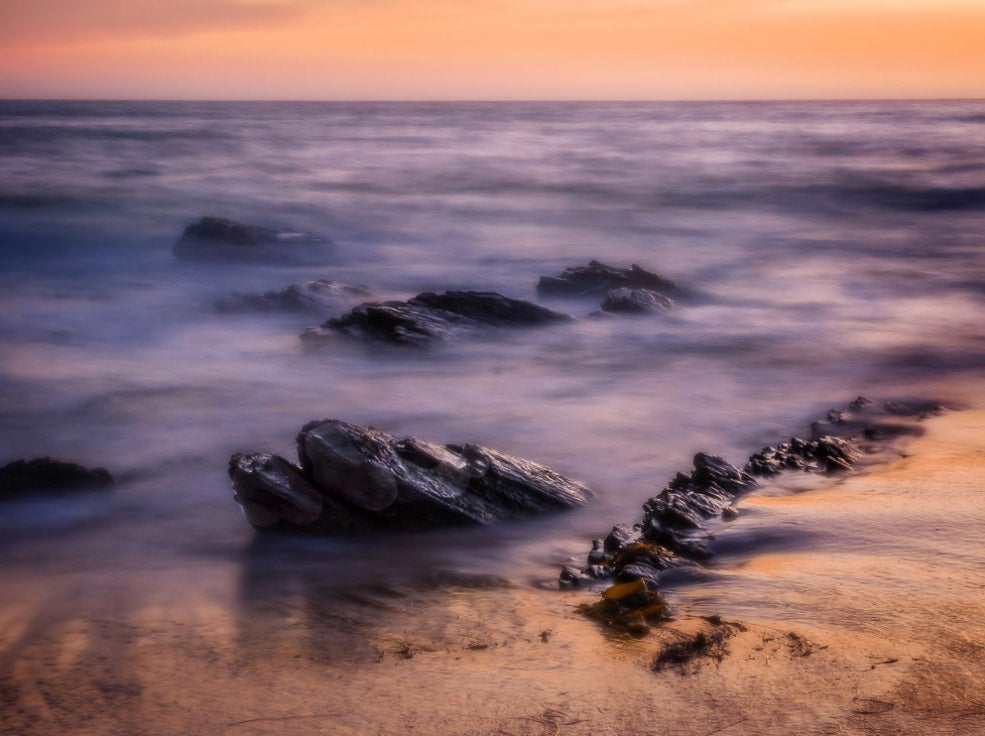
<box><xmin>301</xmin><ymin>291</ymin><xmax>571</xmax><ymax>345</ymax></box>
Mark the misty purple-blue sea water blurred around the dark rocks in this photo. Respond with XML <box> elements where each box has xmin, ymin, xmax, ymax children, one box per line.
<box><xmin>0</xmin><ymin>101</ymin><xmax>985</xmax><ymax>620</ymax></box>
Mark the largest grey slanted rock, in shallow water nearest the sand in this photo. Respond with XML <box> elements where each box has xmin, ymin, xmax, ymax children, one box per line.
<box><xmin>229</xmin><ymin>419</ymin><xmax>593</xmax><ymax>534</ymax></box>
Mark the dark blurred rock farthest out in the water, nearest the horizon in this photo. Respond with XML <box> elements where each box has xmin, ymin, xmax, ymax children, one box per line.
<box><xmin>173</xmin><ymin>217</ymin><xmax>331</xmax><ymax>261</ymax></box>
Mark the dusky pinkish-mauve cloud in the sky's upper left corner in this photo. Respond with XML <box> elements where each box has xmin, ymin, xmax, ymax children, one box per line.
<box><xmin>0</xmin><ymin>0</ymin><xmax>311</xmax><ymax>44</ymax></box>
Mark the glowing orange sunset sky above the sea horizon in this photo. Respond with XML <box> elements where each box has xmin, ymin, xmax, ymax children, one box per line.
<box><xmin>0</xmin><ymin>0</ymin><xmax>985</xmax><ymax>100</ymax></box>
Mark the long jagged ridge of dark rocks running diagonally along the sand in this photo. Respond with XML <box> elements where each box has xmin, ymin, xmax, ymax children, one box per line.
<box><xmin>560</xmin><ymin>397</ymin><xmax>943</xmax><ymax>629</ymax></box>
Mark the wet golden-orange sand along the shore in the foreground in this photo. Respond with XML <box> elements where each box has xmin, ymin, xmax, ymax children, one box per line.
<box><xmin>0</xmin><ymin>411</ymin><xmax>985</xmax><ymax>736</ymax></box>
